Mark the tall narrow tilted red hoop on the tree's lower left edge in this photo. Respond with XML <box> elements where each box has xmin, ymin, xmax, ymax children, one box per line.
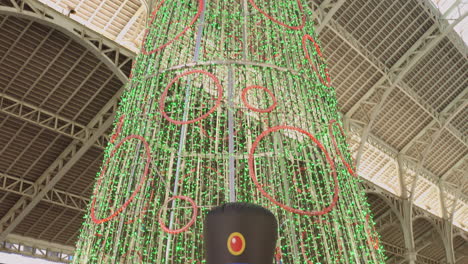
<box><xmin>91</xmin><ymin>135</ymin><xmax>151</xmax><ymax>224</ymax></box>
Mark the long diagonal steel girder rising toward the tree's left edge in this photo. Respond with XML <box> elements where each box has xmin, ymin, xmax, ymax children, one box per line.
<box><xmin>0</xmin><ymin>88</ymin><xmax>123</xmax><ymax>241</ymax></box>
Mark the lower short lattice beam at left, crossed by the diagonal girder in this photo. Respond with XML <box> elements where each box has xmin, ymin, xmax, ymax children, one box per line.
<box><xmin>0</xmin><ymin>173</ymin><xmax>89</xmax><ymax>212</ymax></box>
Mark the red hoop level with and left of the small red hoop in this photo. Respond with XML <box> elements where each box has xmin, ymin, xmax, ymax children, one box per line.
<box><xmin>159</xmin><ymin>70</ymin><xmax>223</xmax><ymax>125</ymax></box>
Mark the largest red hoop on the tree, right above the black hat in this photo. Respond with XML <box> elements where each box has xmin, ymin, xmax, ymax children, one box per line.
<box><xmin>249</xmin><ymin>126</ymin><xmax>339</xmax><ymax>216</ymax></box>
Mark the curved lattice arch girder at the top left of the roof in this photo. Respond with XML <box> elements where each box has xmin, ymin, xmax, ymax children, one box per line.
<box><xmin>0</xmin><ymin>0</ymin><xmax>135</xmax><ymax>83</ymax></box>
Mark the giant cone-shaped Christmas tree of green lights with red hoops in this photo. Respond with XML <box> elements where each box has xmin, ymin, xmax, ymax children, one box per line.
<box><xmin>74</xmin><ymin>0</ymin><xmax>384</xmax><ymax>264</ymax></box>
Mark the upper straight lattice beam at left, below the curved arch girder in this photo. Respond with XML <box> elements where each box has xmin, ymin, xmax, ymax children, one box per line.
<box><xmin>0</xmin><ymin>92</ymin><xmax>107</xmax><ymax>149</ymax></box>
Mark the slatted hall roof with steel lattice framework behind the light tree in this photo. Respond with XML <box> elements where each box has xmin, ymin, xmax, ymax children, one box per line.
<box><xmin>0</xmin><ymin>0</ymin><xmax>468</xmax><ymax>263</ymax></box>
